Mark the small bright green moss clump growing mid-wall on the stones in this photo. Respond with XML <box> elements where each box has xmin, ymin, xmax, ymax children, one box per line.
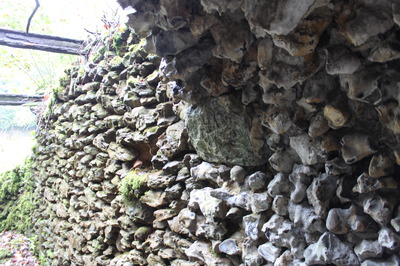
<box><xmin>118</xmin><ymin>171</ymin><xmax>148</xmax><ymax>202</ymax></box>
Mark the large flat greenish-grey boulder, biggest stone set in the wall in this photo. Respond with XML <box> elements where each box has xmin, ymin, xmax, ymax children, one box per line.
<box><xmin>186</xmin><ymin>96</ymin><xmax>267</xmax><ymax>166</ymax></box>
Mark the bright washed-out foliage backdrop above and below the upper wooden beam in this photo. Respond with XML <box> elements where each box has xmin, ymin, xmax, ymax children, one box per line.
<box><xmin>0</xmin><ymin>0</ymin><xmax>120</xmax><ymax>94</ymax></box>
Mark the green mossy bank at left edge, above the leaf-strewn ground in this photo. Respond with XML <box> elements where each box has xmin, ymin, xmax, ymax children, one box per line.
<box><xmin>0</xmin><ymin>161</ymin><xmax>35</xmax><ymax>233</ymax></box>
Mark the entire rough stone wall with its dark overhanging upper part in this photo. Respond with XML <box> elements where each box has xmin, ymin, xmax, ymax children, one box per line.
<box><xmin>31</xmin><ymin>0</ymin><xmax>400</xmax><ymax>265</ymax></box>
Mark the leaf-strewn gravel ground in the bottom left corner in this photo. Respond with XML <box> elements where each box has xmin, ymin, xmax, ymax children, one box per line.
<box><xmin>0</xmin><ymin>231</ymin><xmax>40</xmax><ymax>266</ymax></box>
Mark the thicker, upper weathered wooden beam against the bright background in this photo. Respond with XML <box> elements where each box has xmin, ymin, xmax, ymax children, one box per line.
<box><xmin>0</xmin><ymin>29</ymin><xmax>85</xmax><ymax>55</ymax></box>
